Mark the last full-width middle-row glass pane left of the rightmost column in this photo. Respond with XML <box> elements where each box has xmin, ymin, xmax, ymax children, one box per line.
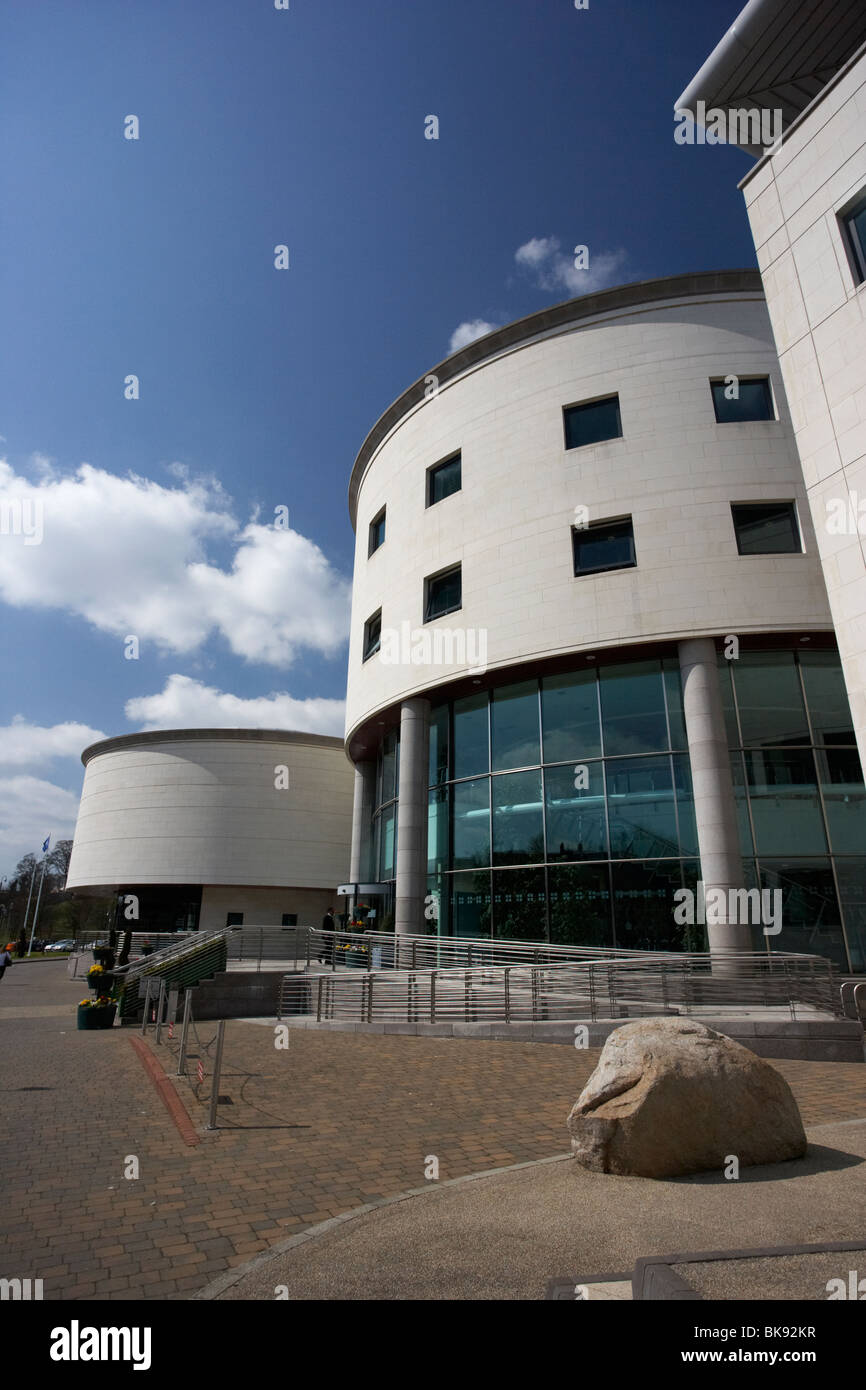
<box><xmin>606</xmin><ymin>756</ymin><xmax>680</xmax><ymax>859</ymax></box>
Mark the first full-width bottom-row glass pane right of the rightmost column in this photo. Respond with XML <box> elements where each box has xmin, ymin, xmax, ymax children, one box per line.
<box><xmin>760</xmin><ymin>859</ymin><xmax>848</xmax><ymax>970</ymax></box>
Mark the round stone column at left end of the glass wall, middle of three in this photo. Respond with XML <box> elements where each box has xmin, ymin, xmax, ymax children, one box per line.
<box><xmin>393</xmin><ymin>699</ymin><xmax>430</xmax><ymax>934</ymax></box>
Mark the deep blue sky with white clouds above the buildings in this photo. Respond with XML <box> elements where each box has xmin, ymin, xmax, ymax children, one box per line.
<box><xmin>0</xmin><ymin>0</ymin><xmax>755</xmax><ymax>874</ymax></box>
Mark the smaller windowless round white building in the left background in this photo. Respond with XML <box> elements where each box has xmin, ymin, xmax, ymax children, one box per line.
<box><xmin>67</xmin><ymin>728</ymin><xmax>352</xmax><ymax>931</ymax></box>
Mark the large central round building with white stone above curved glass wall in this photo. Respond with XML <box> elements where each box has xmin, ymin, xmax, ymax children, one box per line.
<box><xmin>346</xmin><ymin>271</ymin><xmax>866</xmax><ymax>969</ymax></box>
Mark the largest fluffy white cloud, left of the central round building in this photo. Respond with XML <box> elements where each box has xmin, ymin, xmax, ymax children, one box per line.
<box><xmin>0</xmin><ymin>457</ymin><xmax>350</xmax><ymax>666</ymax></box>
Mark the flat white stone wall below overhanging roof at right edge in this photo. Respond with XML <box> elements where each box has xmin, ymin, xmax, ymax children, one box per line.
<box><xmin>741</xmin><ymin>49</ymin><xmax>866</xmax><ymax>766</ymax></box>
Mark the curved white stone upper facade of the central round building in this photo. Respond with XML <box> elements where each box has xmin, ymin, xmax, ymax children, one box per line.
<box><xmin>346</xmin><ymin>272</ymin><xmax>831</xmax><ymax>749</ymax></box>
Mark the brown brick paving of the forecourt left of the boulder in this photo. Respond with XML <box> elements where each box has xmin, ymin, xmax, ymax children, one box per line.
<box><xmin>0</xmin><ymin>963</ymin><xmax>866</xmax><ymax>1300</ymax></box>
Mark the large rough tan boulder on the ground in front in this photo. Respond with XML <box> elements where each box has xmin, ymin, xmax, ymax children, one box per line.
<box><xmin>569</xmin><ymin>1019</ymin><xmax>806</xmax><ymax>1177</ymax></box>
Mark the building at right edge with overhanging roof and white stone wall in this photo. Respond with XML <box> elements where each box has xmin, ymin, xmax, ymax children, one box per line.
<box><xmin>677</xmin><ymin>0</ymin><xmax>866</xmax><ymax>800</ymax></box>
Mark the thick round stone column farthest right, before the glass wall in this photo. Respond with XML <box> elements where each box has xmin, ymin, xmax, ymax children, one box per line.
<box><xmin>680</xmin><ymin>637</ymin><xmax>752</xmax><ymax>956</ymax></box>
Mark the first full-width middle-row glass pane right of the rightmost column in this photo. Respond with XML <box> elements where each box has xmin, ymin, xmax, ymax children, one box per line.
<box><xmin>745</xmin><ymin>748</ymin><xmax>827</xmax><ymax>856</ymax></box>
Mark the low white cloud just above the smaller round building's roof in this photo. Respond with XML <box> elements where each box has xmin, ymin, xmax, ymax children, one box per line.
<box><xmin>124</xmin><ymin>676</ymin><xmax>345</xmax><ymax>737</ymax></box>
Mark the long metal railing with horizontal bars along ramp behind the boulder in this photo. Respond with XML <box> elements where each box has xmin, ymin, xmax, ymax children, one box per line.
<box><xmin>279</xmin><ymin>952</ymin><xmax>840</xmax><ymax>1023</ymax></box>
